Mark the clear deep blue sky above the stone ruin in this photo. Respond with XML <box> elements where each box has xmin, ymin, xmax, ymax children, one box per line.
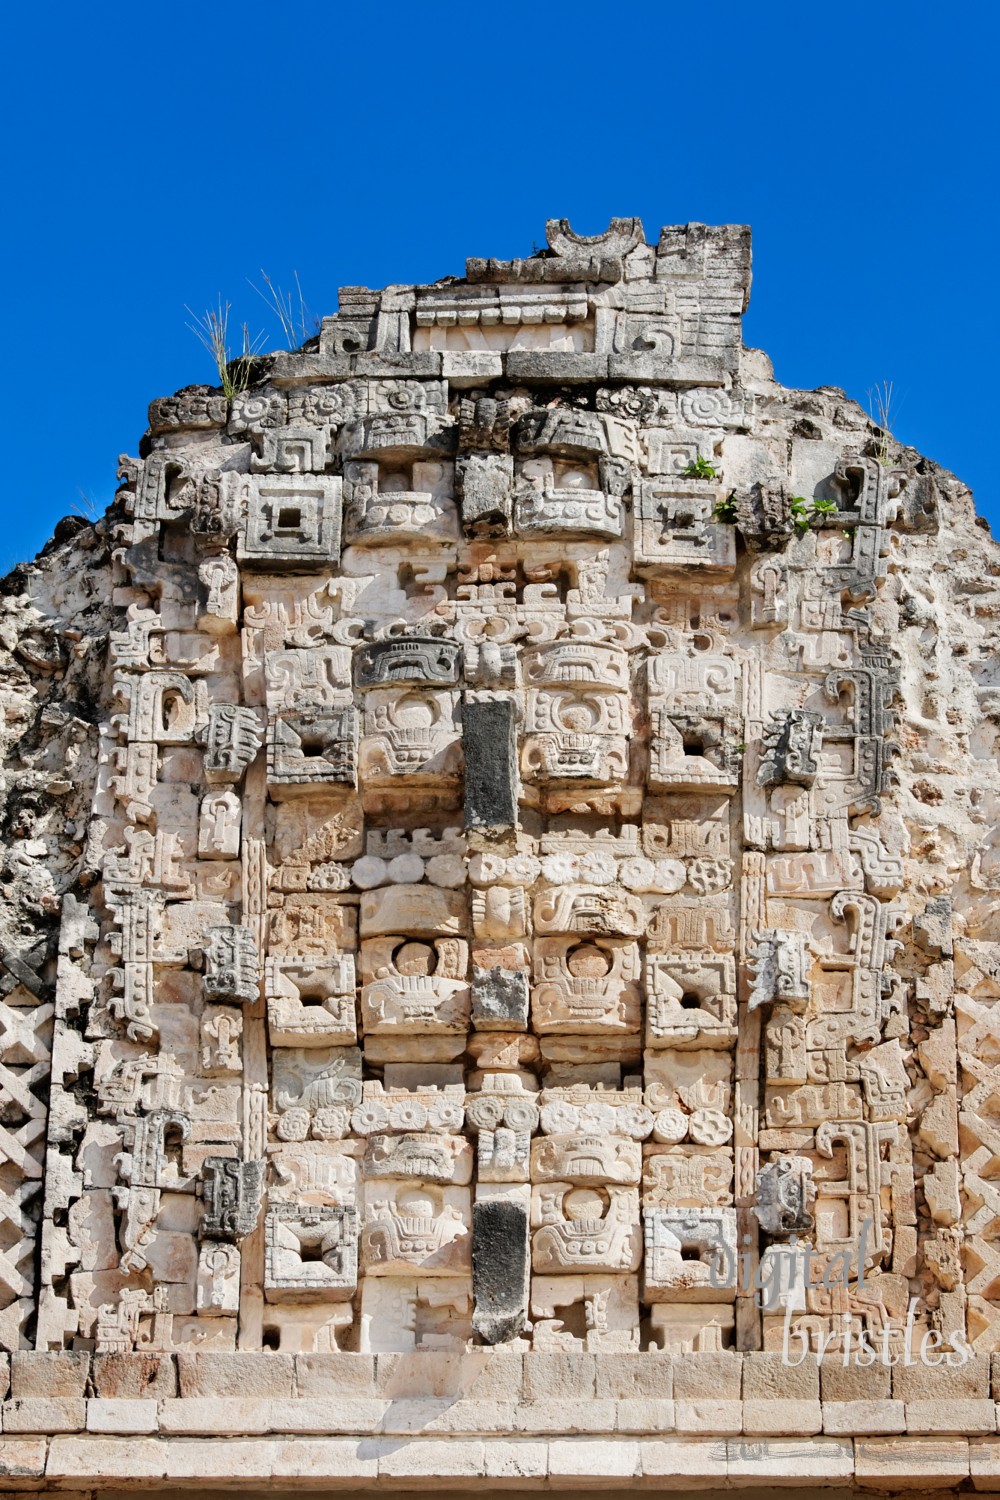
<box><xmin>0</xmin><ymin>0</ymin><xmax>1000</xmax><ymax>572</ymax></box>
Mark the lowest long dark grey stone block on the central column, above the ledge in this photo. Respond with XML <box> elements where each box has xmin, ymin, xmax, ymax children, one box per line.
<box><xmin>472</xmin><ymin>1199</ymin><xmax>529</xmax><ymax>1344</ymax></box>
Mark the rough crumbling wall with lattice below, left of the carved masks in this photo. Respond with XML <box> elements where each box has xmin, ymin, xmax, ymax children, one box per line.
<box><xmin>0</xmin><ymin>518</ymin><xmax>114</xmax><ymax>1349</ymax></box>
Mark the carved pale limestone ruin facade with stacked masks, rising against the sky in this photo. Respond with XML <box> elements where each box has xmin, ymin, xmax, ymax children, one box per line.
<box><xmin>0</xmin><ymin>219</ymin><xmax>1000</xmax><ymax>1488</ymax></box>
